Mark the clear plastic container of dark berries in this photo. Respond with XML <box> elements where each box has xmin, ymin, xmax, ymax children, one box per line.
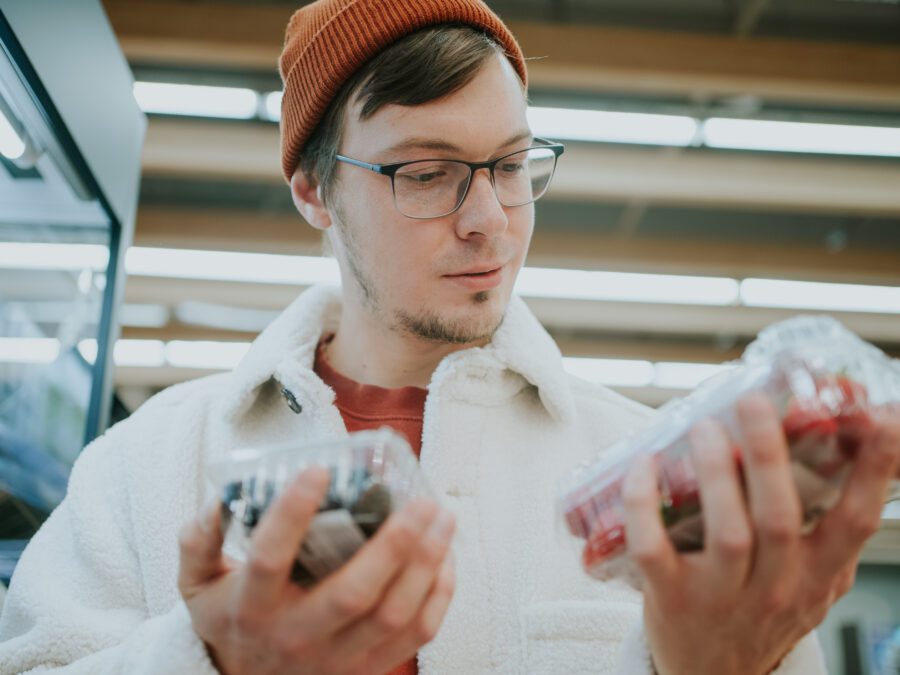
<box><xmin>207</xmin><ymin>428</ymin><xmax>434</xmax><ymax>586</ymax></box>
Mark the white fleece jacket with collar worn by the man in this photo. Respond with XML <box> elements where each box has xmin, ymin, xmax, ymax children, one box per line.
<box><xmin>0</xmin><ymin>288</ymin><xmax>825</xmax><ymax>675</ymax></box>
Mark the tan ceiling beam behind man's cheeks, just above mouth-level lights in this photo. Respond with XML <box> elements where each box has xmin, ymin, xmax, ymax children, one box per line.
<box><xmin>134</xmin><ymin>205</ymin><xmax>900</xmax><ymax>285</ymax></box>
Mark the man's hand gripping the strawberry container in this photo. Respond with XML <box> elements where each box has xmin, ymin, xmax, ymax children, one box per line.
<box><xmin>623</xmin><ymin>394</ymin><xmax>900</xmax><ymax>675</ymax></box>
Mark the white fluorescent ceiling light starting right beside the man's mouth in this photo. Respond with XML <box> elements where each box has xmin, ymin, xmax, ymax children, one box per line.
<box><xmin>516</xmin><ymin>267</ymin><xmax>739</xmax><ymax>305</ymax></box>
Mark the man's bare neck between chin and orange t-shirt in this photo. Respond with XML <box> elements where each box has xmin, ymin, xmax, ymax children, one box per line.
<box><xmin>328</xmin><ymin>304</ymin><xmax>486</xmax><ymax>389</ymax></box>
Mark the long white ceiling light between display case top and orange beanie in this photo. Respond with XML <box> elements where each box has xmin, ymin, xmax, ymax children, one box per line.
<box><xmin>134</xmin><ymin>82</ymin><xmax>259</xmax><ymax>119</ymax></box>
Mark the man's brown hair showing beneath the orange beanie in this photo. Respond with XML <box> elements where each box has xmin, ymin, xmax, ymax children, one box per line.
<box><xmin>300</xmin><ymin>24</ymin><xmax>520</xmax><ymax>205</ymax></box>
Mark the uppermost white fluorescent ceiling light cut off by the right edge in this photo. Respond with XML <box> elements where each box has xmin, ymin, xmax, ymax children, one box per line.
<box><xmin>702</xmin><ymin>117</ymin><xmax>900</xmax><ymax>157</ymax></box>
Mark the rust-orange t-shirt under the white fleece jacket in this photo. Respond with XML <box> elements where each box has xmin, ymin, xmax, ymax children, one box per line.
<box><xmin>313</xmin><ymin>336</ymin><xmax>428</xmax><ymax>675</ymax></box>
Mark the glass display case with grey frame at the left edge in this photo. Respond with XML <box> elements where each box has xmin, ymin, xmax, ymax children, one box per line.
<box><xmin>0</xmin><ymin>0</ymin><xmax>146</xmax><ymax>581</ymax></box>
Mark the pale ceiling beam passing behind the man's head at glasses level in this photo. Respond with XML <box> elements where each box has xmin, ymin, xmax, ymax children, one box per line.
<box><xmin>143</xmin><ymin>117</ymin><xmax>900</xmax><ymax>216</ymax></box>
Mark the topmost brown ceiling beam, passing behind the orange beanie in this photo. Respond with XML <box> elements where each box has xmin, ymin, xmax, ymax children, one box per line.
<box><xmin>105</xmin><ymin>0</ymin><xmax>900</xmax><ymax>110</ymax></box>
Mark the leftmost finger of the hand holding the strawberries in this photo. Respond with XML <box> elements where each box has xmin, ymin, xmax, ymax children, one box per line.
<box><xmin>622</xmin><ymin>455</ymin><xmax>678</xmax><ymax>589</ymax></box>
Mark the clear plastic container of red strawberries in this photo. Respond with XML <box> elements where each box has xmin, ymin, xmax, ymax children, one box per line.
<box><xmin>558</xmin><ymin>316</ymin><xmax>900</xmax><ymax>585</ymax></box>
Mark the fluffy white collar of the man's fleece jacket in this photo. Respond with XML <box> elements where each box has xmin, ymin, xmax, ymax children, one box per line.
<box><xmin>222</xmin><ymin>286</ymin><xmax>575</xmax><ymax>422</ymax></box>
